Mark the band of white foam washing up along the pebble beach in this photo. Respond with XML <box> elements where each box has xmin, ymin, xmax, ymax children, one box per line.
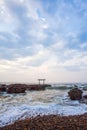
<box><xmin>0</xmin><ymin>104</ymin><xmax>87</xmax><ymax>126</ymax></box>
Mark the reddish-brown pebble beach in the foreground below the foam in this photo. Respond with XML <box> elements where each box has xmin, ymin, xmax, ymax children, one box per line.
<box><xmin>0</xmin><ymin>113</ymin><xmax>87</xmax><ymax>130</ymax></box>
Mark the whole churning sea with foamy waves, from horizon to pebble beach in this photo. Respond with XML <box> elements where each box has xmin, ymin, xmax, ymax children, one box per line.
<box><xmin>0</xmin><ymin>83</ymin><xmax>87</xmax><ymax>127</ymax></box>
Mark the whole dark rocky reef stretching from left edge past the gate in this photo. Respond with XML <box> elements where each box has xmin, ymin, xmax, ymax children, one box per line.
<box><xmin>0</xmin><ymin>84</ymin><xmax>51</xmax><ymax>94</ymax></box>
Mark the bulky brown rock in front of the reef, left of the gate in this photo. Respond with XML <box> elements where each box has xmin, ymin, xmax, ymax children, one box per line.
<box><xmin>6</xmin><ymin>84</ymin><xmax>26</xmax><ymax>93</ymax></box>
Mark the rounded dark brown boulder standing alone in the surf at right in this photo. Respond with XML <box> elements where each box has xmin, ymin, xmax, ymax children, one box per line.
<box><xmin>68</xmin><ymin>88</ymin><xmax>83</xmax><ymax>100</ymax></box>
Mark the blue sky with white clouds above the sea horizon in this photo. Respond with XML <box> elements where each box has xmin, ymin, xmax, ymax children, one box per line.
<box><xmin>0</xmin><ymin>0</ymin><xmax>87</xmax><ymax>82</ymax></box>
